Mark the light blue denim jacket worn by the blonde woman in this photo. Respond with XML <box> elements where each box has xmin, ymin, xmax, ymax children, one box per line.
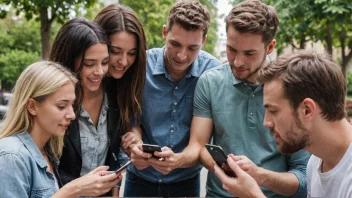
<box><xmin>0</xmin><ymin>132</ymin><xmax>60</xmax><ymax>198</ymax></box>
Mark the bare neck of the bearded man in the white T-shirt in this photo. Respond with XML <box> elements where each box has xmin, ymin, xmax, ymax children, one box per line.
<box><xmin>306</xmin><ymin>118</ymin><xmax>352</xmax><ymax>171</ymax></box>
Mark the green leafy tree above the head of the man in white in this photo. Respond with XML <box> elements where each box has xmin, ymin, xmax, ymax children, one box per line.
<box><xmin>233</xmin><ymin>0</ymin><xmax>352</xmax><ymax>75</ymax></box>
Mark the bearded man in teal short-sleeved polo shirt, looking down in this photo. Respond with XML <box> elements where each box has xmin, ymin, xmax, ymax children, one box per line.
<box><xmin>179</xmin><ymin>0</ymin><xmax>310</xmax><ymax>197</ymax></box>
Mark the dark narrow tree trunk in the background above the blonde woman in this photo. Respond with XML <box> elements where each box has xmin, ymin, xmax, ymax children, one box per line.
<box><xmin>40</xmin><ymin>7</ymin><xmax>51</xmax><ymax>60</ymax></box>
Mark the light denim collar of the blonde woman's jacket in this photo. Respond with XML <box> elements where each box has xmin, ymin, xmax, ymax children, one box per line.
<box><xmin>16</xmin><ymin>132</ymin><xmax>48</xmax><ymax>168</ymax></box>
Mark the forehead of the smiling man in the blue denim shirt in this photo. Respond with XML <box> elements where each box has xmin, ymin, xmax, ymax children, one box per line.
<box><xmin>166</xmin><ymin>24</ymin><xmax>203</xmax><ymax>46</ymax></box>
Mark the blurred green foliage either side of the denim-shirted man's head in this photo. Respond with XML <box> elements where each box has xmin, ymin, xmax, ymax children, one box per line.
<box><xmin>120</xmin><ymin>0</ymin><xmax>217</xmax><ymax>54</ymax></box>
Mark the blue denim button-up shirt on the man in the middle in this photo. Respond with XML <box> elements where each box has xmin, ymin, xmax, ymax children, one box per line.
<box><xmin>129</xmin><ymin>48</ymin><xmax>221</xmax><ymax>183</ymax></box>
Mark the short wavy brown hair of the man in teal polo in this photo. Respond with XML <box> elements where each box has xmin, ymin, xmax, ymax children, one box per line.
<box><xmin>225</xmin><ymin>0</ymin><xmax>279</xmax><ymax>45</ymax></box>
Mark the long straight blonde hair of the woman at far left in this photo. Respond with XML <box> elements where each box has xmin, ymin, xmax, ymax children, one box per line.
<box><xmin>0</xmin><ymin>61</ymin><xmax>77</xmax><ymax>159</ymax></box>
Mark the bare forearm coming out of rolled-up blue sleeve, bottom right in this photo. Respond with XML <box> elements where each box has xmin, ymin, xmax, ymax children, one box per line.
<box><xmin>254</xmin><ymin>168</ymin><xmax>299</xmax><ymax>196</ymax></box>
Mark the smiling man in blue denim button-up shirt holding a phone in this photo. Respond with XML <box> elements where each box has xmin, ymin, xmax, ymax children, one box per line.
<box><xmin>124</xmin><ymin>1</ymin><xmax>220</xmax><ymax>197</ymax></box>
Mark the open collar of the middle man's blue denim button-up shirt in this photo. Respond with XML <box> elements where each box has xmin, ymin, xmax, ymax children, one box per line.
<box><xmin>153</xmin><ymin>46</ymin><xmax>201</xmax><ymax>77</ymax></box>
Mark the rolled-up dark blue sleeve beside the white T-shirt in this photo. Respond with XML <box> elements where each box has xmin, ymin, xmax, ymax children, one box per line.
<box><xmin>287</xmin><ymin>150</ymin><xmax>311</xmax><ymax>198</ymax></box>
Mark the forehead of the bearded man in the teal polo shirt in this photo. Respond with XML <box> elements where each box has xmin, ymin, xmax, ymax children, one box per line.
<box><xmin>227</xmin><ymin>26</ymin><xmax>264</xmax><ymax>51</ymax></box>
